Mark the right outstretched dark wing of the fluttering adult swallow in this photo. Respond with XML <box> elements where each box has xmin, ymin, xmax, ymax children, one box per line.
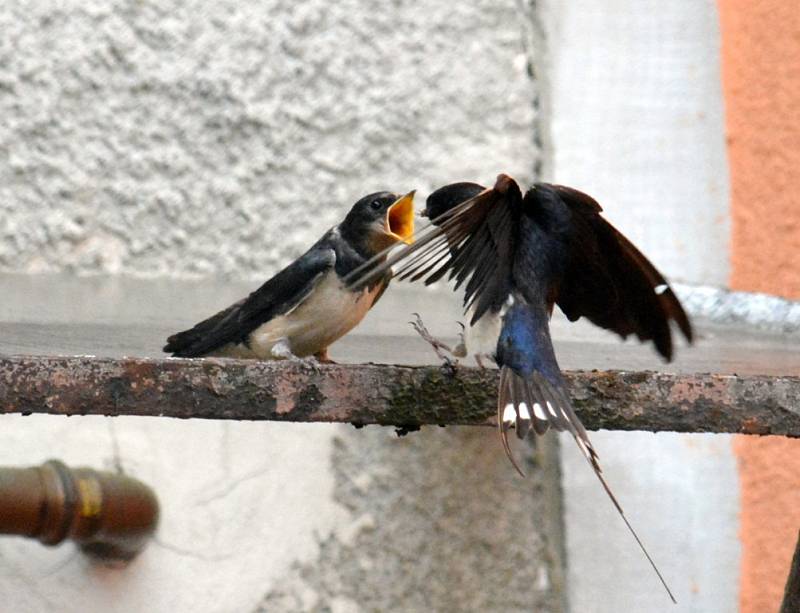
<box><xmin>536</xmin><ymin>183</ymin><xmax>692</xmax><ymax>360</ymax></box>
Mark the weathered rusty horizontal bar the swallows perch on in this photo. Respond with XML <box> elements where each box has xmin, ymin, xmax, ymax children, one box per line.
<box><xmin>0</xmin><ymin>356</ymin><xmax>800</xmax><ymax>437</ymax></box>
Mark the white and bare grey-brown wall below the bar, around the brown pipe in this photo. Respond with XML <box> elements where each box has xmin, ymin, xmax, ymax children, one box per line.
<box><xmin>0</xmin><ymin>417</ymin><xmax>563</xmax><ymax>613</ymax></box>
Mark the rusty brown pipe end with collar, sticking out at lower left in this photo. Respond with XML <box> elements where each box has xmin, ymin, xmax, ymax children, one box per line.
<box><xmin>0</xmin><ymin>460</ymin><xmax>158</xmax><ymax>560</ymax></box>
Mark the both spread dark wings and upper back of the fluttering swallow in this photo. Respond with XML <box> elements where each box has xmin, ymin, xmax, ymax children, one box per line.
<box><xmin>348</xmin><ymin>175</ymin><xmax>692</xmax><ymax>359</ymax></box>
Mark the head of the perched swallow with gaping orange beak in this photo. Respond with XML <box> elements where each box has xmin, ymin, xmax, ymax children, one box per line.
<box><xmin>339</xmin><ymin>191</ymin><xmax>414</xmax><ymax>255</ymax></box>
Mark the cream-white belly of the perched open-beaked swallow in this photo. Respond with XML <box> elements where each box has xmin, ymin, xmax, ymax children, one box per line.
<box><xmin>217</xmin><ymin>271</ymin><xmax>380</xmax><ymax>359</ymax></box>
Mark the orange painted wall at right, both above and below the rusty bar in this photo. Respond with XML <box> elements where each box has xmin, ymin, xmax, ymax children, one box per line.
<box><xmin>719</xmin><ymin>0</ymin><xmax>800</xmax><ymax>613</ymax></box>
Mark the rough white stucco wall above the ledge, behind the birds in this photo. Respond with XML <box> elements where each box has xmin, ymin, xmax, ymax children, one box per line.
<box><xmin>0</xmin><ymin>0</ymin><xmax>537</xmax><ymax>276</ymax></box>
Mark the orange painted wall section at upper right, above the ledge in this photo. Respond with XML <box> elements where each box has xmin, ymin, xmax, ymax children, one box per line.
<box><xmin>719</xmin><ymin>0</ymin><xmax>800</xmax><ymax>298</ymax></box>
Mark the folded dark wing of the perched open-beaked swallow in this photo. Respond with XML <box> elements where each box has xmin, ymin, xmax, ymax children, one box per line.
<box><xmin>164</xmin><ymin>248</ymin><xmax>336</xmax><ymax>358</ymax></box>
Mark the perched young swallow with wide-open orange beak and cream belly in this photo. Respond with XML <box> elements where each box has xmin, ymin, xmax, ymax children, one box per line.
<box><xmin>164</xmin><ymin>191</ymin><xmax>414</xmax><ymax>361</ymax></box>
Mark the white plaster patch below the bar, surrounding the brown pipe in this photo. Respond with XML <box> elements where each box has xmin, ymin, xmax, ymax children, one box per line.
<box><xmin>0</xmin><ymin>416</ymin><xmax>348</xmax><ymax>613</ymax></box>
